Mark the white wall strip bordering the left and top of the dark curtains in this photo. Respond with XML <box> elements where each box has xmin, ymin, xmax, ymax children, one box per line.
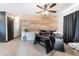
<box><xmin>58</xmin><ymin>4</ymin><xmax>79</xmax><ymax>34</ymax></box>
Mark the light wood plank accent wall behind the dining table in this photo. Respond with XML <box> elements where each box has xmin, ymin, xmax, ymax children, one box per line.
<box><xmin>21</xmin><ymin>16</ymin><xmax>58</xmax><ymax>31</ymax></box>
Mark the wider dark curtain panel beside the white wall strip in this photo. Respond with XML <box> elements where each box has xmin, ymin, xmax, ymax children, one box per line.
<box><xmin>63</xmin><ymin>12</ymin><xmax>76</xmax><ymax>43</ymax></box>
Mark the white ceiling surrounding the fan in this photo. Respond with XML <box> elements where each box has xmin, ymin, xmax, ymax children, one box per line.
<box><xmin>0</xmin><ymin>3</ymin><xmax>74</xmax><ymax>16</ymax></box>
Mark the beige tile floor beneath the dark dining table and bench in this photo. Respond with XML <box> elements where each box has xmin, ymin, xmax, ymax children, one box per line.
<box><xmin>0</xmin><ymin>37</ymin><xmax>79</xmax><ymax>56</ymax></box>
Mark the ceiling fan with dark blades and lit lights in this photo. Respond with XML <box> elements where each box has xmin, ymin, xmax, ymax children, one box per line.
<box><xmin>36</xmin><ymin>3</ymin><xmax>56</xmax><ymax>16</ymax></box>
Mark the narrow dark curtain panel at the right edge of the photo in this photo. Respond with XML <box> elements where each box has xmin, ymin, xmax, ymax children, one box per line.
<box><xmin>74</xmin><ymin>11</ymin><xmax>79</xmax><ymax>42</ymax></box>
